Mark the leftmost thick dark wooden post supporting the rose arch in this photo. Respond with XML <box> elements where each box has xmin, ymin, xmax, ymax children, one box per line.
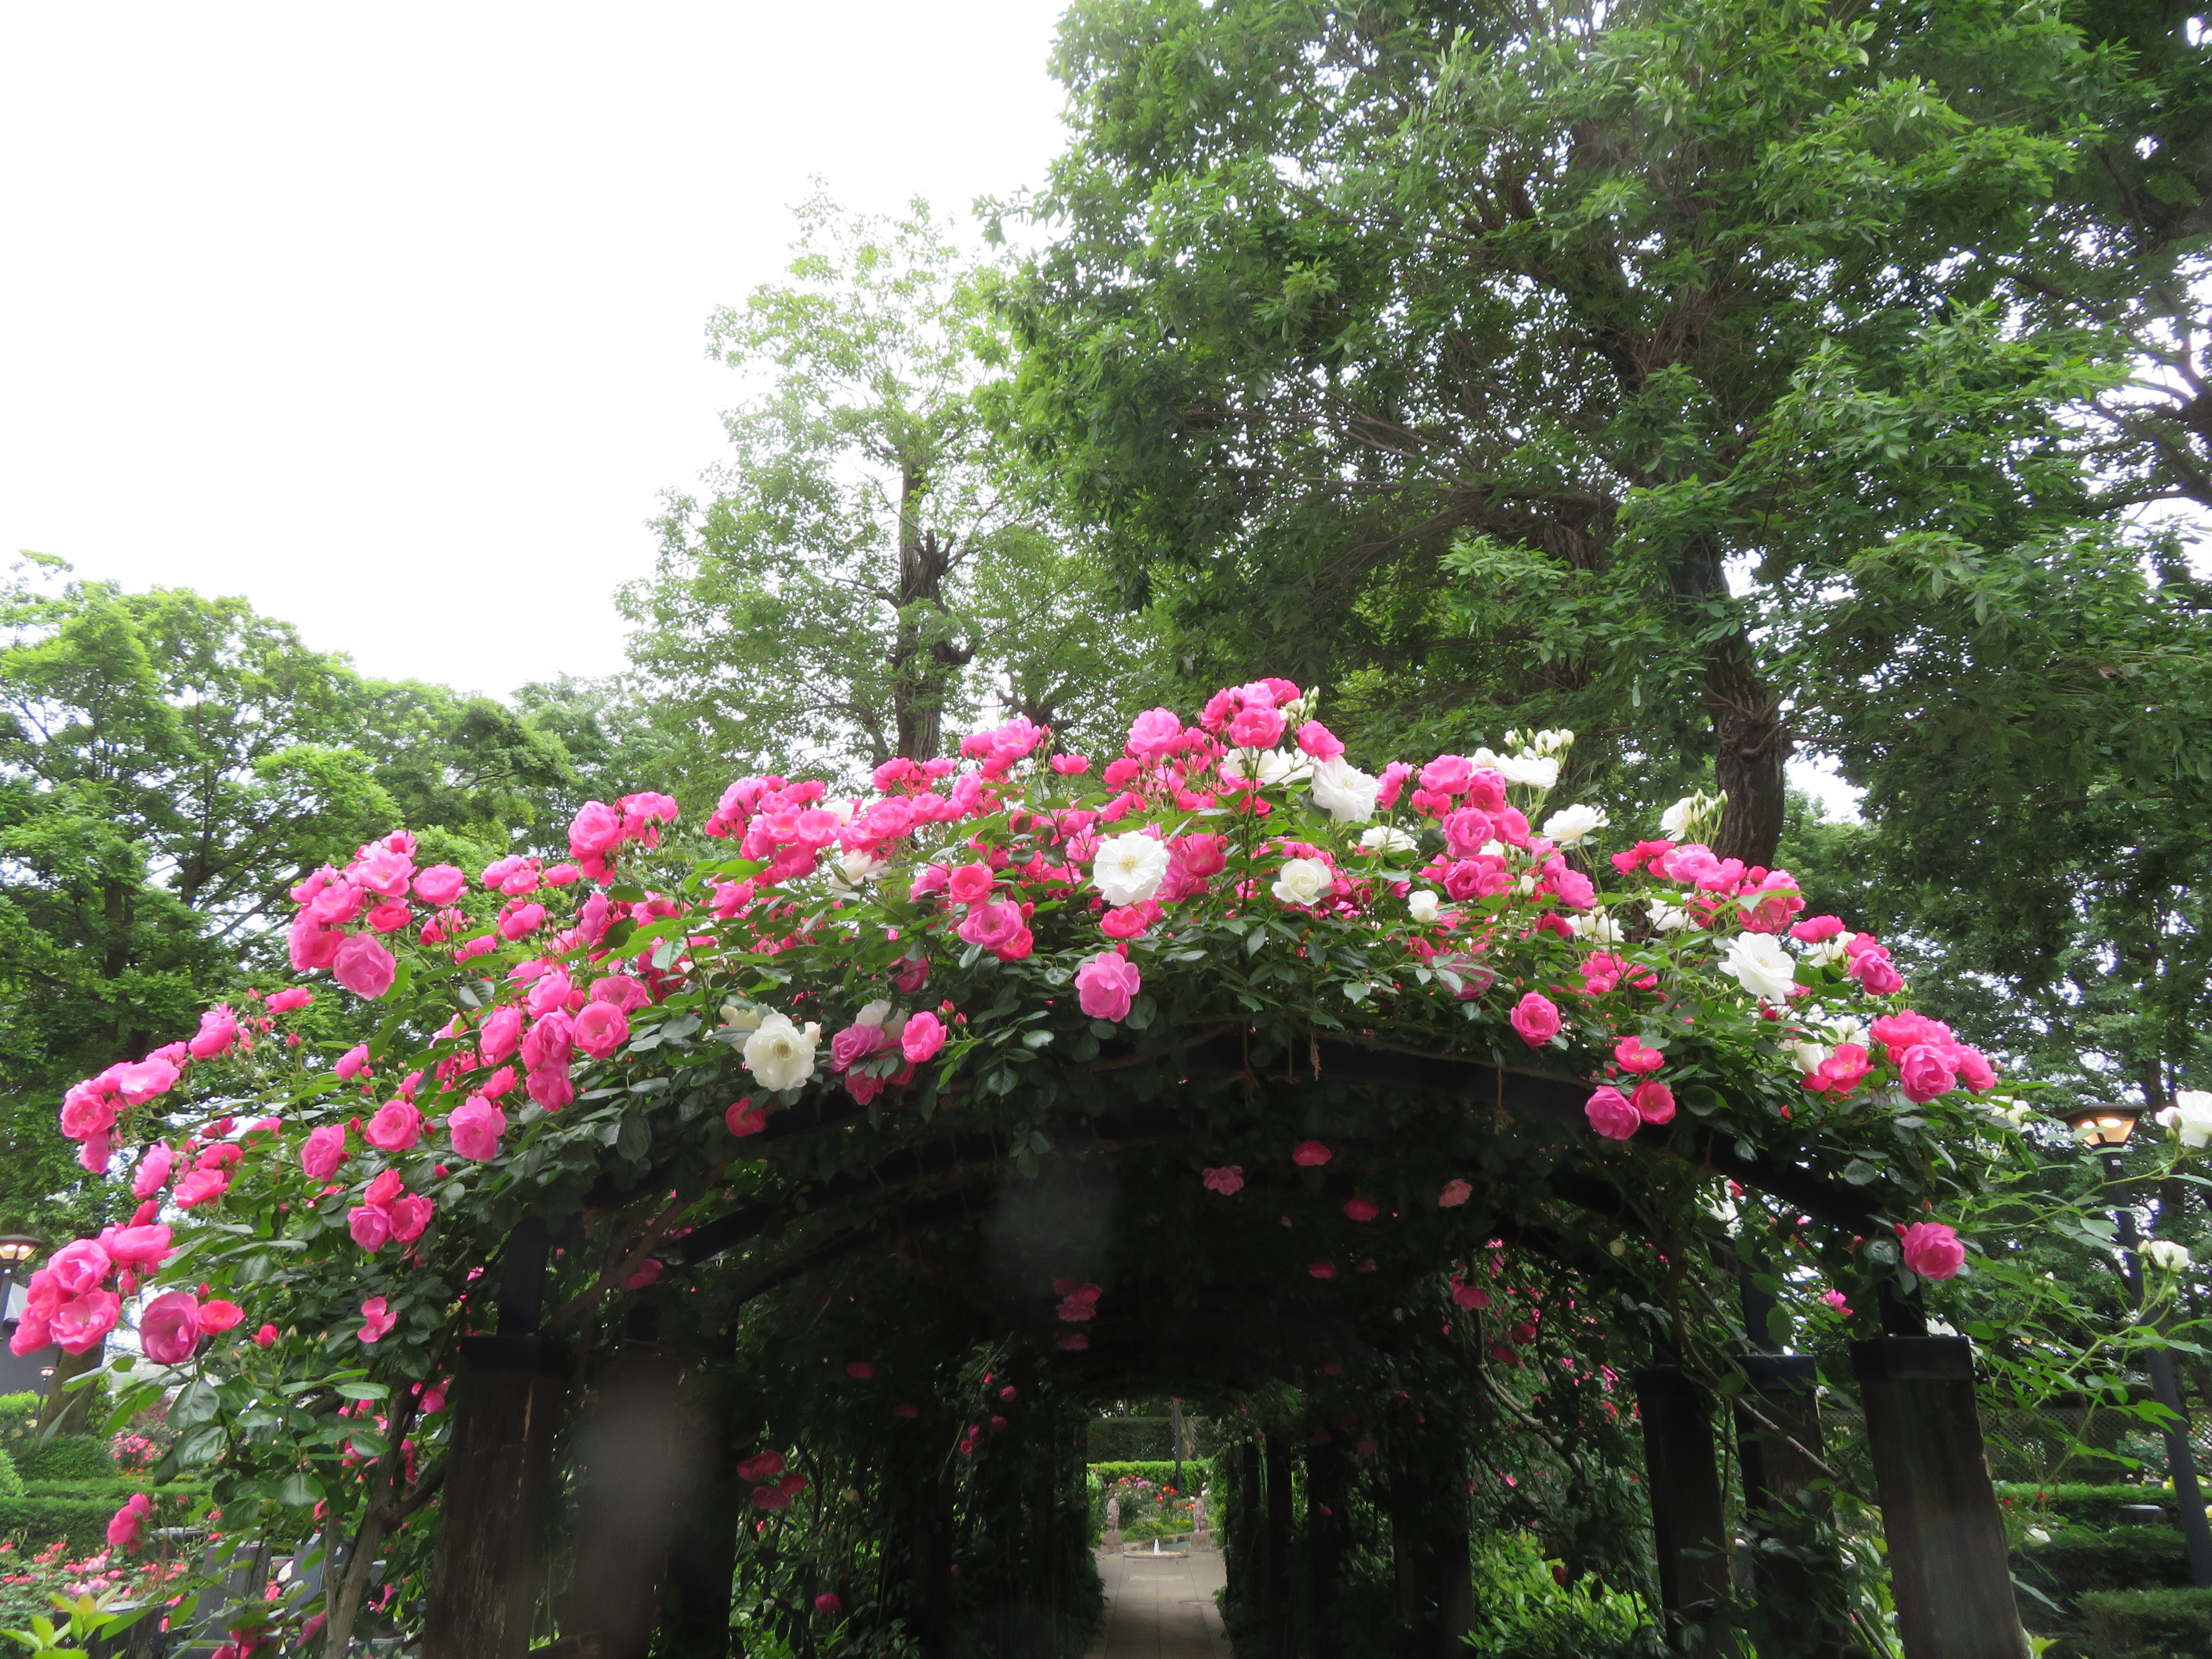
<box><xmin>422</xmin><ymin>1336</ymin><xmax>566</xmax><ymax>1659</ymax></box>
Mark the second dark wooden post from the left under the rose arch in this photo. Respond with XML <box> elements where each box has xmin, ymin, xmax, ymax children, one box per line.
<box><xmin>562</xmin><ymin>1307</ymin><xmax>677</xmax><ymax>1659</ymax></box>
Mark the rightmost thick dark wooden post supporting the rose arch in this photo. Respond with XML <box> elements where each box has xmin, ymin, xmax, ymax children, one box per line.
<box><xmin>1851</xmin><ymin>1336</ymin><xmax>2029</xmax><ymax>1659</ymax></box>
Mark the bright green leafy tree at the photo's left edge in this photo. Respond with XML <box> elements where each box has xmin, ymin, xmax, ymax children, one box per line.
<box><xmin>0</xmin><ymin>557</ymin><xmax>593</xmax><ymax>1234</ymax></box>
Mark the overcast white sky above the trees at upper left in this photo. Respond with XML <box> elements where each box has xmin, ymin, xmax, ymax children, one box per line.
<box><xmin>0</xmin><ymin>0</ymin><xmax>1062</xmax><ymax>693</ymax></box>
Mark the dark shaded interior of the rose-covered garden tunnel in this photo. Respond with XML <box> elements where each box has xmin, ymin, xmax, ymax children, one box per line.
<box><xmin>427</xmin><ymin>1048</ymin><xmax>2008</xmax><ymax>1659</ymax></box>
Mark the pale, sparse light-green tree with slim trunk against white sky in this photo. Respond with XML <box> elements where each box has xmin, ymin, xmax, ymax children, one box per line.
<box><xmin>622</xmin><ymin>197</ymin><xmax>1176</xmax><ymax>787</ymax></box>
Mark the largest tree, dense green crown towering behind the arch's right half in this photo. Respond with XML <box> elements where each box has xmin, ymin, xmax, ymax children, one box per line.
<box><xmin>1009</xmin><ymin>0</ymin><xmax>2117</xmax><ymax>863</ymax></box>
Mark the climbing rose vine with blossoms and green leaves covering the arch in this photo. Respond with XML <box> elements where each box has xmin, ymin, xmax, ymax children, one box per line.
<box><xmin>13</xmin><ymin>679</ymin><xmax>2011</xmax><ymax>1637</ymax></box>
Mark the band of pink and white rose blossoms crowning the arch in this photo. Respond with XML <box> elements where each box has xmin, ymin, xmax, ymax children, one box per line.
<box><xmin>52</xmin><ymin>679</ymin><xmax>1993</xmax><ymax>1389</ymax></box>
